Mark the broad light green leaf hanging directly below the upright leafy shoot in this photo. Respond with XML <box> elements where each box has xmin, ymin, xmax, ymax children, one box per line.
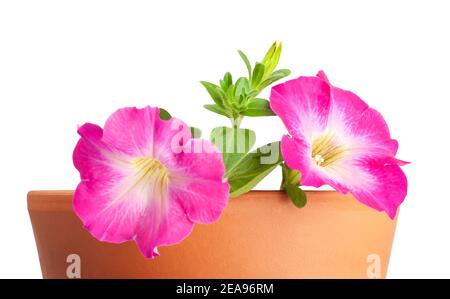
<box><xmin>211</xmin><ymin>127</ymin><xmax>256</xmax><ymax>172</ymax></box>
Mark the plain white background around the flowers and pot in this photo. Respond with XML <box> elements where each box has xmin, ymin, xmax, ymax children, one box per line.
<box><xmin>0</xmin><ymin>0</ymin><xmax>450</xmax><ymax>278</ymax></box>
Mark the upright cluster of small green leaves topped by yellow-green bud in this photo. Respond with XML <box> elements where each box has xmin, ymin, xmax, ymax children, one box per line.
<box><xmin>201</xmin><ymin>42</ymin><xmax>290</xmax><ymax>123</ymax></box>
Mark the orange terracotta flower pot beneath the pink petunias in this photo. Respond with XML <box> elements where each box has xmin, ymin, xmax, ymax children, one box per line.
<box><xmin>28</xmin><ymin>191</ymin><xmax>397</xmax><ymax>278</ymax></box>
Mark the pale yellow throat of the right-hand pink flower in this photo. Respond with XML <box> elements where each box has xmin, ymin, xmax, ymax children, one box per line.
<box><xmin>311</xmin><ymin>133</ymin><xmax>346</xmax><ymax>167</ymax></box>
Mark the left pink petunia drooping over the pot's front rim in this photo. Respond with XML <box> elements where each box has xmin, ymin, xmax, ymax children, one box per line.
<box><xmin>73</xmin><ymin>107</ymin><xmax>229</xmax><ymax>258</ymax></box>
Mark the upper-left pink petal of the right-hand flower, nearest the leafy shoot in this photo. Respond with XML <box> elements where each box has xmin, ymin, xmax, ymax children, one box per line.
<box><xmin>270</xmin><ymin>77</ymin><xmax>330</xmax><ymax>138</ymax></box>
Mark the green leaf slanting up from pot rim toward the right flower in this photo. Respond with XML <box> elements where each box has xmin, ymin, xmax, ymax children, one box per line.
<box><xmin>227</xmin><ymin>142</ymin><xmax>283</xmax><ymax>197</ymax></box>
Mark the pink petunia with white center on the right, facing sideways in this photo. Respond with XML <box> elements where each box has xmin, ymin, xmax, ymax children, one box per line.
<box><xmin>270</xmin><ymin>72</ymin><xmax>407</xmax><ymax>218</ymax></box>
